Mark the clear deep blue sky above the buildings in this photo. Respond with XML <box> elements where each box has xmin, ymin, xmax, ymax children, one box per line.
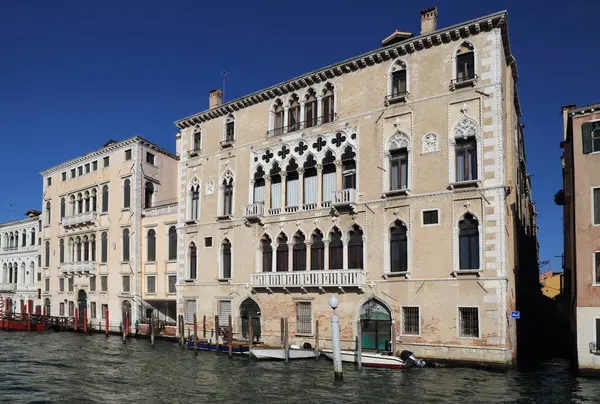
<box><xmin>0</xmin><ymin>0</ymin><xmax>600</xmax><ymax>270</ymax></box>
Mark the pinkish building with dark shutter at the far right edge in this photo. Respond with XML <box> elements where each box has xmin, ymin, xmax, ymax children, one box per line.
<box><xmin>557</xmin><ymin>104</ymin><xmax>600</xmax><ymax>373</ymax></box>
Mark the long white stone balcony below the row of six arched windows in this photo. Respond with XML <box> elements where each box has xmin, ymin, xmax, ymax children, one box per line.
<box><xmin>250</xmin><ymin>269</ymin><xmax>366</xmax><ymax>292</ymax></box>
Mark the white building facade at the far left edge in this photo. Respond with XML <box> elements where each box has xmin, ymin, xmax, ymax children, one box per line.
<box><xmin>0</xmin><ymin>210</ymin><xmax>41</xmax><ymax>313</ymax></box>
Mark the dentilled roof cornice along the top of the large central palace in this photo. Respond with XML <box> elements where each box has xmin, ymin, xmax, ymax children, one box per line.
<box><xmin>175</xmin><ymin>11</ymin><xmax>521</xmax><ymax>129</ymax></box>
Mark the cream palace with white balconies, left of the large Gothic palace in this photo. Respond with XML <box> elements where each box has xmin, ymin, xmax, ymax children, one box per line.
<box><xmin>40</xmin><ymin>137</ymin><xmax>177</xmax><ymax>330</ymax></box>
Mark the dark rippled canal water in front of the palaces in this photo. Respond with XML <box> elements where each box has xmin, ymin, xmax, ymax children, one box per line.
<box><xmin>0</xmin><ymin>332</ymin><xmax>600</xmax><ymax>404</ymax></box>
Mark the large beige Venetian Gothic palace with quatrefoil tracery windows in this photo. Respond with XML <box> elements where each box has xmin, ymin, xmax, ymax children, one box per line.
<box><xmin>171</xmin><ymin>9</ymin><xmax>537</xmax><ymax>364</ymax></box>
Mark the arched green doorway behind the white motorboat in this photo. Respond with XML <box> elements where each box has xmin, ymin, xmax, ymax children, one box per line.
<box><xmin>360</xmin><ymin>299</ymin><xmax>392</xmax><ymax>351</ymax></box>
